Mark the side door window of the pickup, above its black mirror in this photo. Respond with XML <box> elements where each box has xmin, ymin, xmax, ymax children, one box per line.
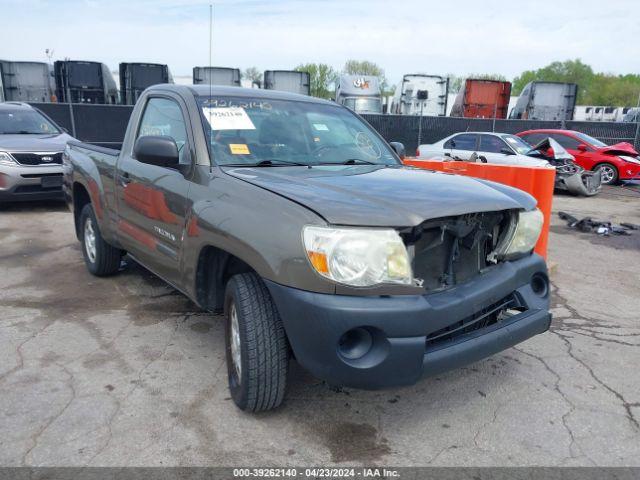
<box><xmin>136</xmin><ymin>98</ymin><xmax>189</xmax><ymax>165</ymax></box>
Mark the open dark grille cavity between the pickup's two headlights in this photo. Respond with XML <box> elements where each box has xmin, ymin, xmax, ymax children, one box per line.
<box><xmin>404</xmin><ymin>210</ymin><xmax>514</xmax><ymax>292</ymax></box>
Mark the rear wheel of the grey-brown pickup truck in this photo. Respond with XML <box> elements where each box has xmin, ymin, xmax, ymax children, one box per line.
<box><xmin>80</xmin><ymin>203</ymin><xmax>122</xmax><ymax>277</ymax></box>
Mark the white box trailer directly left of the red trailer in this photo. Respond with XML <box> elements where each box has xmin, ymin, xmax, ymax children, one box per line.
<box><xmin>388</xmin><ymin>73</ymin><xmax>449</xmax><ymax>116</ymax></box>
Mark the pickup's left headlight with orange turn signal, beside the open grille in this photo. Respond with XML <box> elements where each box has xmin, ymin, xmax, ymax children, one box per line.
<box><xmin>302</xmin><ymin>226</ymin><xmax>412</xmax><ymax>287</ymax></box>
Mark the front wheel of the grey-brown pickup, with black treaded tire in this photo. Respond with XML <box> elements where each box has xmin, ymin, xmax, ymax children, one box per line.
<box><xmin>224</xmin><ymin>273</ymin><xmax>289</xmax><ymax>412</ymax></box>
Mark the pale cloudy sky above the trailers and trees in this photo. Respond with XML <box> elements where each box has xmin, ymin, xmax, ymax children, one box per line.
<box><xmin>0</xmin><ymin>0</ymin><xmax>640</xmax><ymax>84</ymax></box>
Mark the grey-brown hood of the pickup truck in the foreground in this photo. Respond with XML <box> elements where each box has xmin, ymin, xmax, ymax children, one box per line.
<box><xmin>224</xmin><ymin>165</ymin><xmax>536</xmax><ymax>227</ymax></box>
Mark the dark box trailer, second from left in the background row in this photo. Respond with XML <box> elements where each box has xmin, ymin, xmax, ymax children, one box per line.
<box><xmin>53</xmin><ymin>60</ymin><xmax>118</xmax><ymax>104</ymax></box>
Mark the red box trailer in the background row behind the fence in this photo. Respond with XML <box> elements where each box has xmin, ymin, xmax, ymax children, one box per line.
<box><xmin>450</xmin><ymin>78</ymin><xmax>511</xmax><ymax>118</ymax></box>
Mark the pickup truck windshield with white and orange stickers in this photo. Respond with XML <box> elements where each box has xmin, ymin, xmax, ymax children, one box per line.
<box><xmin>200</xmin><ymin>97</ymin><xmax>398</xmax><ymax>166</ymax></box>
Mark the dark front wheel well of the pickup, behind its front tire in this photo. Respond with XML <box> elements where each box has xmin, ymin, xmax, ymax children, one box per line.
<box><xmin>196</xmin><ymin>246</ymin><xmax>255</xmax><ymax>312</ymax></box>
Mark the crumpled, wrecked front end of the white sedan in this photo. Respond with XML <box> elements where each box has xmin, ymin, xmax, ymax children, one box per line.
<box><xmin>527</xmin><ymin>138</ymin><xmax>602</xmax><ymax>197</ymax></box>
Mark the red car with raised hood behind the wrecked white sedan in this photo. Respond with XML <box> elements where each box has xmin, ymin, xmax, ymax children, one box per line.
<box><xmin>517</xmin><ymin>130</ymin><xmax>640</xmax><ymax>185</ymax></box>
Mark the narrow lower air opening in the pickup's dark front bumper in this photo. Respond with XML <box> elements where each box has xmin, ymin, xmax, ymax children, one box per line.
<box><xmin>426</xmin><ymin>294</ymin><xmax>525</xmax><ymax>350</ymax></box>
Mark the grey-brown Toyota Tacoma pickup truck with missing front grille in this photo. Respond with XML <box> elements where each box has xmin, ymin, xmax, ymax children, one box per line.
<box><xmin>63</xmin><ymin>85</ymin><xmax>551</xmax><ymax>411</ymax></box>
